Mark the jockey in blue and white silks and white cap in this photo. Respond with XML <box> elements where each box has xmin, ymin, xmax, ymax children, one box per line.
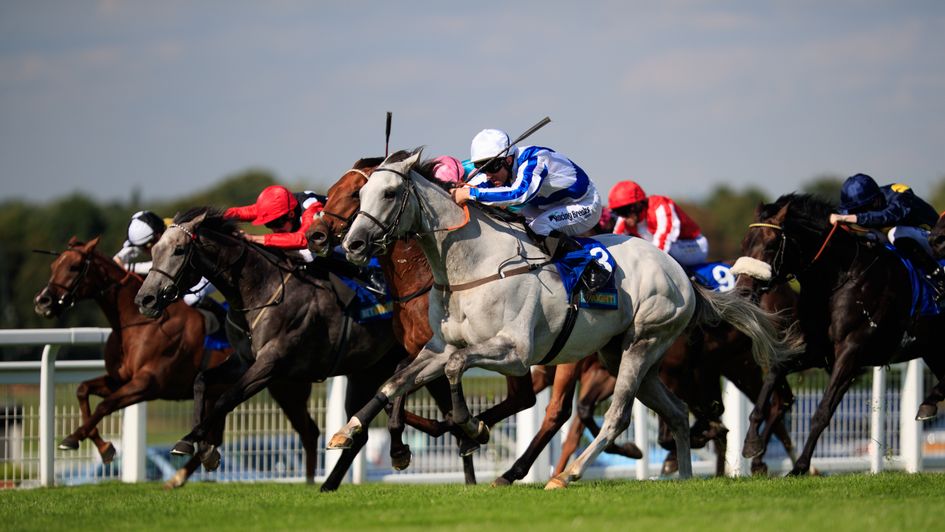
<box><xmin>460</xmin><ymin>129</ymin><xmax>601</xmax><ymax>236</ymax></box>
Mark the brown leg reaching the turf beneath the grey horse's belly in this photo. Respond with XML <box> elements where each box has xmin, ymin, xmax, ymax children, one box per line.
<box><xmin>492</xmin><ymin>362</ymin><xmax>581</xmax><ymax>486</ymax></box>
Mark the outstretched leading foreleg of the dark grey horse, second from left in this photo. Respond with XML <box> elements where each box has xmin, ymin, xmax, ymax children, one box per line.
<box><xmin>171</xmin><ymin>352</ymin><xmax>279</xmax><ymax>455</ymax></box>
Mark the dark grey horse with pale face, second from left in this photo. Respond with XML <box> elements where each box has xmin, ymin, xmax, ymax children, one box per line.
<box><xmin>135</xmin><ymin>207</ymin><xmax>405</xmax><ymax>491</ymax></box>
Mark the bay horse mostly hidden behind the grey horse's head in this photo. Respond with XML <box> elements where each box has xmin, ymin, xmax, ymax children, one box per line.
<box><xmin>307</xmin><ymin>158</ymin><xmax>535</xmax><ymax>483</ymax></box>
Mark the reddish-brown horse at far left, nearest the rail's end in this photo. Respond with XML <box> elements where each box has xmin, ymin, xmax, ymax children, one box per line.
<box><xmin>35</xmin><ymin>237</ymin><xmax>318</xmax><ymax>488</ymax></box>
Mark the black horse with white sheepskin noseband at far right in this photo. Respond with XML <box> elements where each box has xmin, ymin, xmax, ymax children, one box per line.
<box><xmin>736</xmin><ymin>194</ymin><xmax>945</xmax><ymax>475</ymax></box>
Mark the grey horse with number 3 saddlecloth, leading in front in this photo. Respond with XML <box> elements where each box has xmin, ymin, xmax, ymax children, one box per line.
<box><xmin>329</xmin><ymin>150</ymin><xmax>796</xmax><ymax>489</ymax></box>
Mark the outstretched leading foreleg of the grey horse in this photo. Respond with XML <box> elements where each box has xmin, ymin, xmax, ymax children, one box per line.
<box><xmin>328</xmin><ymin>344</ymin><xmax>455</xmax><ymax>449</ymax></box>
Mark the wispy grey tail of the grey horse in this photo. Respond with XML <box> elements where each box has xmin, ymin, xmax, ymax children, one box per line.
<box><xmin>691</xmin><ymin>283</ymin><xmax>804</xmax><ymax>369</ymax></box>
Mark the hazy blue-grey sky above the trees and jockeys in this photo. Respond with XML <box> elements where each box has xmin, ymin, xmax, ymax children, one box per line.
<box><xmin>0</xmin><ymin>0</ymin><xmax>945</xmax><ymax>205</ymax></box>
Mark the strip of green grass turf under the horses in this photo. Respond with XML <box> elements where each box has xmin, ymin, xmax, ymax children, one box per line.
<box><xmin>0</xmin><ymin>473</ymin><xmax>945</xmax><ymax>531</ymax></box>
